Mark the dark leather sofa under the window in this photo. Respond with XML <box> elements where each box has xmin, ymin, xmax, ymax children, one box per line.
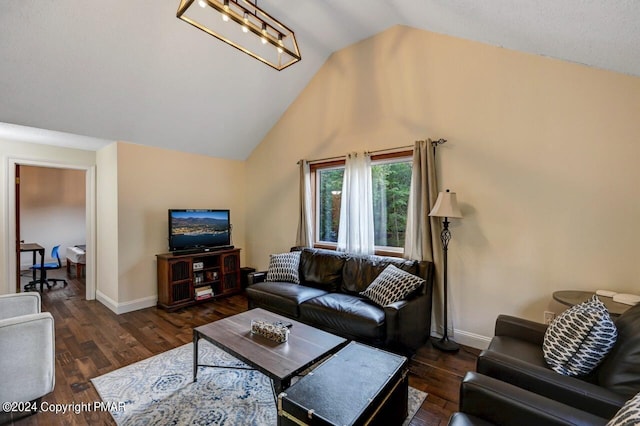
<box><xmin>247</xmin><ymin>248</ymin><xmax>434</xmax><ymax>352</ymax></box>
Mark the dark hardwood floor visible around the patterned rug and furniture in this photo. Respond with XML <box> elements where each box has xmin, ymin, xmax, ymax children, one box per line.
<box><xmin>9</xmin><ymin>270</ymin><xmax>478</xmax><ymax>426</ymax></box>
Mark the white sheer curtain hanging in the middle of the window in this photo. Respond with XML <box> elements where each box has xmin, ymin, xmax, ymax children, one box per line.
<box><xmin>338</xmin><ymin>152</ymin><xmax>375</xmax><ymax>254</ymax></box>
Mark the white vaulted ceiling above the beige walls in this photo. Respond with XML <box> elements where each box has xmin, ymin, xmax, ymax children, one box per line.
<box><xmin>0</xmin><ymin>0</ymin><xmax>640</xmax><ymax>160</ymax></box>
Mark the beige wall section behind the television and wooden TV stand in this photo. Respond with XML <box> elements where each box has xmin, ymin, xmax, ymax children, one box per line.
<box><xmin>109</xmin><ymin>142</ymin><xmax>246</xmax><ymax>310</ymax></box>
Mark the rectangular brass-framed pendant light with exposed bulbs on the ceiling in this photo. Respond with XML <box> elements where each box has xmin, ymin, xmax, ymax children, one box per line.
<box><xmin>176</xmin><ymin>0</ymin><xmax>301</xmax><ymax>71</ymax></box>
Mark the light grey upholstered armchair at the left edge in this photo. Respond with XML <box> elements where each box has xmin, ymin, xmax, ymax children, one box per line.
<box><xmin>0</xmin><ymin>292</ymin><xmax>55</xmax><ymax>410</ymax></box>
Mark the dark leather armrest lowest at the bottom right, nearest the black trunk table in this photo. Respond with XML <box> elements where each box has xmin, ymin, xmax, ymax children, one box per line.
<box><xmin>460</xmin><ymin>372</ymin><xmax>607</xmax><ymax>426</ymax></box>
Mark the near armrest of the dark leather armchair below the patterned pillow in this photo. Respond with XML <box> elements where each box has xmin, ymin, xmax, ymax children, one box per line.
<box><xmin>476</xmin><ymin>350</ymin><xmax>627</xmax><ymax>419</ymax></box>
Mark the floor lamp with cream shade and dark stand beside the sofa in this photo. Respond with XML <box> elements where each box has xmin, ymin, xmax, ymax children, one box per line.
<box><xmin>429</xmin><ymin>189</ymin><xmax>462</xmax><ymax>352</ymax></box>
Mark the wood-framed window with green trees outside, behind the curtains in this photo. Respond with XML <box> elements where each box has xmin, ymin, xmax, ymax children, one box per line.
<box><xmin>311</xmin><ymin>151</ymin><xmax>412</xmax><ymax>253</ymax></box>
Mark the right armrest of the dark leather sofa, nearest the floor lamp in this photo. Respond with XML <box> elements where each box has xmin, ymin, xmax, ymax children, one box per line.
<box><xmin>384</xmin><ymin>286</ymin><xmax>431</xmax><ymax>351</ymax></box>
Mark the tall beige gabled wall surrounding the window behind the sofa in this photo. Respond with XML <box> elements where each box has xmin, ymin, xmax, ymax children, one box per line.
<box><xmin>247</xmin><ymin>27</ymin><xmax>640</xmax><ymax>344</ymax></box>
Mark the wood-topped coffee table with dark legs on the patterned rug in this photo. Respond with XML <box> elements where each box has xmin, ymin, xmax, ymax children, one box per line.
<box><xmin>193</xmin><ymin>308</ymin><xmax>348</xmax><ymax>395</ymax></box>
